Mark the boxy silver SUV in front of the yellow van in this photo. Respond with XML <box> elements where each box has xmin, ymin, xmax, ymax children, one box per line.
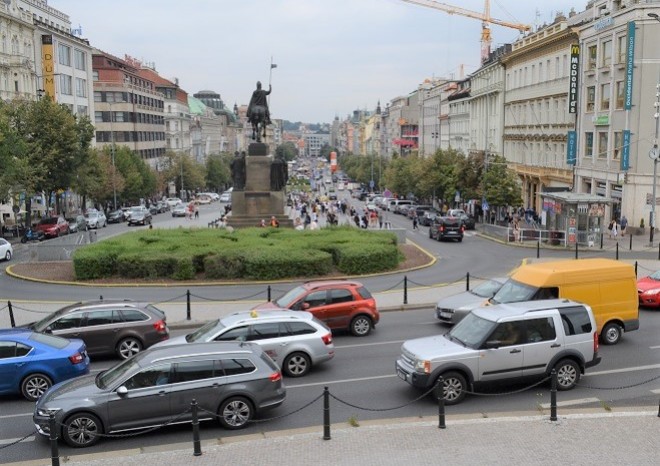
<box><xmin>396</xmin><ymin>299</ymin><xmax>600</xmax><ymax>404</ymax></box>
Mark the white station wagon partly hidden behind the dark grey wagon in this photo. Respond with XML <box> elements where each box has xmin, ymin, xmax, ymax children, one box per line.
<box><xmin>155</xmin><ymin>309</ymin><xmax>335</xmax><ymax>377</ymax></box>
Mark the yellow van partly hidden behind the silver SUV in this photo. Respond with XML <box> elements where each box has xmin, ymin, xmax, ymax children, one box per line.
<box><xmin>490</xmin><ymin>259</ymin><xmax>639</xmax><ymax>345</ymax></box>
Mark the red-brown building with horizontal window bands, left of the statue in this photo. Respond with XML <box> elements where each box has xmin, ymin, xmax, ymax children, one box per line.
<box><xmin>92</xmin><ymin>49</ymin><xmax>165</xmax><ymax>168</ymax></box>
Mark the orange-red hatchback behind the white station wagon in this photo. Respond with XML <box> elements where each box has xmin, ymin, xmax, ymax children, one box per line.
<box><xmin>255</xmin><ymin>280</ymin><xmax>380</xmax><ymax>337</ymax></box>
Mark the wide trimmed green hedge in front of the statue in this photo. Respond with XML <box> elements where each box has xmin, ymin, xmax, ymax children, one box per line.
<box><xmin>73</xmin><ymin>227</ymin><xmax>403</xmax><ymax>280</ymax></box>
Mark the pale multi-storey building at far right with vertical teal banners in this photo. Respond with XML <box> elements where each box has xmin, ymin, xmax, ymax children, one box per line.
<box><xmin>570</xmin><ymin>0</ymin><xmax>660</xmax><ymax>227</ymax></box>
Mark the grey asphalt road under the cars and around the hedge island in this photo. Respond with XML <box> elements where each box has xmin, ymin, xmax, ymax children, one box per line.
<box><xmin>0</xmin><ymin>197</ymin><xmax>660</xmax><ymax>463</ymax></box>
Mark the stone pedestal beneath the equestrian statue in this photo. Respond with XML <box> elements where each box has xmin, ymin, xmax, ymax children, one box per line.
<box><xmin>227</xmin><ymin>143</ymin><xmax>293</xmax><ymax>228</ymax></box>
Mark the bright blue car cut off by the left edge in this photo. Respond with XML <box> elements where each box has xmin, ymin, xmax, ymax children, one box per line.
<box><xmin>0</xmin><ymin>329</ymin><xmax>89</xmax><ymax>401</ymax></box>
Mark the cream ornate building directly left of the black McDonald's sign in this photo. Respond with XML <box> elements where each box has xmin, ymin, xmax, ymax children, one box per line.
<box><xmin>501</xmin><ymin>16</ymin><xmax>577</xmax><ymax>212</ymax></box>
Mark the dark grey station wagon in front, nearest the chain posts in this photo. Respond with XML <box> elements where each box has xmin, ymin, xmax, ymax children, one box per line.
<box><xmin>33</xmin><ymin>342</ymin><xmax>286</xmax><ymax>447</ymax></box>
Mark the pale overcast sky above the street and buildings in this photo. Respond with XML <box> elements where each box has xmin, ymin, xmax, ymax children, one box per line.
<box><xmin>54</xmin><ymin>0</ymin><xmax>586</xmax><ymax>123</ymax></box>
